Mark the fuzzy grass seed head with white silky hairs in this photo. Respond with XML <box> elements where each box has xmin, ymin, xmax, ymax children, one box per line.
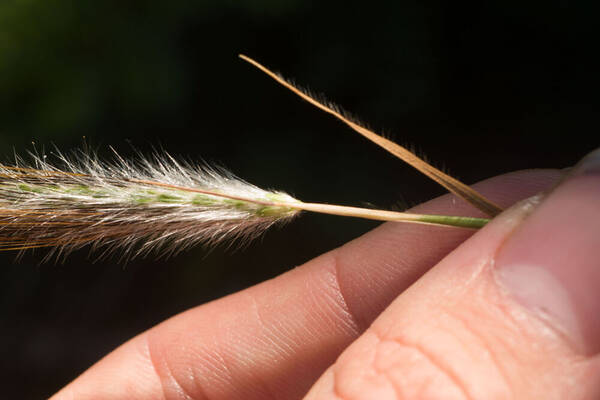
<box><xmin>0</xmin><ymin>152</ymin><xmax>299</xmax><ymax>258</ymax></box>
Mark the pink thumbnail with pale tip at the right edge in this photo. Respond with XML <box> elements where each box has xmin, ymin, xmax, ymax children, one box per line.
<box><xmin>495</xmin><ymin>149</ymin><xmax>600</xmax><ymax>355</ymax></box>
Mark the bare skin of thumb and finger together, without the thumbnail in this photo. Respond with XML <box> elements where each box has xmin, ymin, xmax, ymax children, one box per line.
<box><xmin>52</xmin><ymin>166</ymin><xmax>600</xmax><ymax>400</ymax></box>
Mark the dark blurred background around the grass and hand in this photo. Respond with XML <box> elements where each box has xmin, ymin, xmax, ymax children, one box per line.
<box><xmin>0</xmin><ymin>0</ymin><xmax>600</xmax><ymax>399</ymax></box>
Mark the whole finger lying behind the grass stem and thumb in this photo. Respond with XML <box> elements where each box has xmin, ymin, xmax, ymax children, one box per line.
<box><xmin>56</xmin><ymin>171</ymin><xmax>559</xmax><ymax>399</ymax></box>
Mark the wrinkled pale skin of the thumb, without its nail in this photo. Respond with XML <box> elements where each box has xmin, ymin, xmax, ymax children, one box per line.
<box><xmin>304</xmin><ymin>165</ymin><xmax>600</xmax><ymax>399</ymax></box>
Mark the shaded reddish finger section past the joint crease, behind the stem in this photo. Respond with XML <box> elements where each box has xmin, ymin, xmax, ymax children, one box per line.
<box><xmin>331</xmin><ymin>170</ymin><xmax>562</xmax><ymax>330</ymax></box>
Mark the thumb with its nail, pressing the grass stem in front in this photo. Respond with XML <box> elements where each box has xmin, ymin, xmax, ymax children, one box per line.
<box><xmin>308</xmin><ymin>150</ymin><xmax>600</xmax><ymax>399</ymax></box>
